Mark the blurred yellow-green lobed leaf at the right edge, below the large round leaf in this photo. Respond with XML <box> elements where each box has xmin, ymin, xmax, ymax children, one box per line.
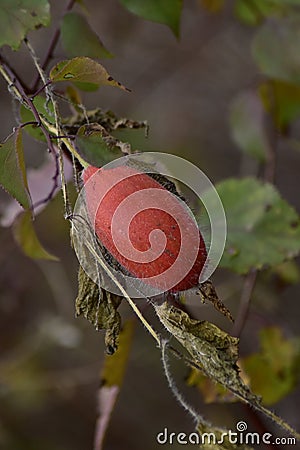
<box><xmin>242</xmin><ymin>327</ymin><xmax>300</xmax><ymax>405</ymax></box>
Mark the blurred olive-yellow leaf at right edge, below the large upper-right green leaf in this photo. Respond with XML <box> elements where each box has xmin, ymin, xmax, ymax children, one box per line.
<box><xmin>259</xmin><ymin>80</ymin><xmax>300</xmax><ymax>131</ymax></box>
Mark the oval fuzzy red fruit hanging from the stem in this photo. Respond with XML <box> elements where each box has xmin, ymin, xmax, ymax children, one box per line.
<box><xmin>83</xmin><ymin>166</ymin><xmax>207</xmax><ymax>292</ymax></box>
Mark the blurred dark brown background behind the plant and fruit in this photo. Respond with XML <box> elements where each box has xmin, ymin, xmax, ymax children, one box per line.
<box><xmin>0</xmin><ymin>0</ymin><xmax>300</xmax><ymax>450</ymax></box>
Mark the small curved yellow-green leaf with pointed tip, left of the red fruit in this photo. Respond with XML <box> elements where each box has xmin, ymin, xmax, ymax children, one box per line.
<box><xmin>13</xmin><ymin>211</ymin><xmax>58</xmax><ymax>261</ymax></box>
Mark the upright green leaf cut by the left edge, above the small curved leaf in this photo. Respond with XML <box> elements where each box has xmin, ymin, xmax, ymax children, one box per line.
<box><xmin>0</xmin><ymin>129</ymin><xmax>31</xmax><ymax>209</ymax></box>
